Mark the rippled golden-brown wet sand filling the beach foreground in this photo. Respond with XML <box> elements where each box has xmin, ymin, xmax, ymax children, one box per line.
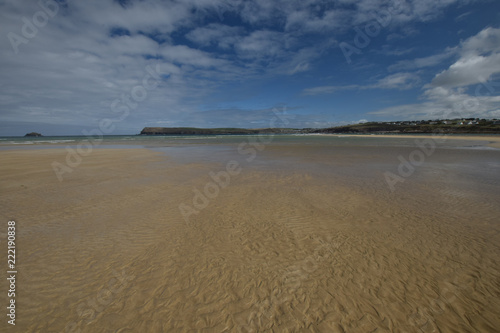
<box><xmin>0</xmin><ymin>136</ymin><xmax>500</xmax><ymax>332</ymax></box>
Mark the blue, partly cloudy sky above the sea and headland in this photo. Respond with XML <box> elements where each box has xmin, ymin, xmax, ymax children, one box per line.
<box><xmin>0</xmin><ymin>0</ymin><xmax>500</xmax><ymax>136</ymax></box>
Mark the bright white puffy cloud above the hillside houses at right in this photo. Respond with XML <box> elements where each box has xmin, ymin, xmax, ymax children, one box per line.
<box><xmin>369</xmin><ymin>27</ymin><xmax>500</xmax><ymax>119</ymax></box>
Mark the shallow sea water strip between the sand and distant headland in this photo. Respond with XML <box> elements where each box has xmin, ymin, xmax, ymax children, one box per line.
<box><xmin>0</xmin><ymin>135</ymin><xmax>500</xmax><ymax>187</ymax></box>
